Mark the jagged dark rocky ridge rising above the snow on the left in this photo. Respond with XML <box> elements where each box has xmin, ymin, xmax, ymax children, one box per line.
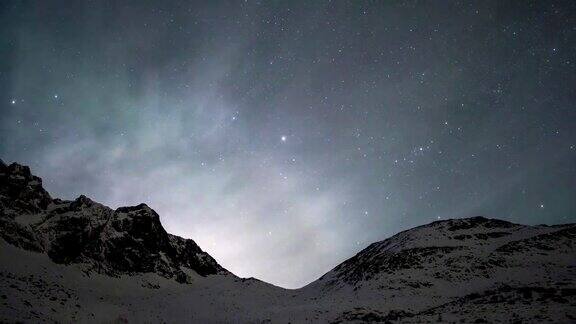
<box><xmin>0</xmin><ymin>163</ymin><xmax>227</xmax><ymax>282</ymax></box>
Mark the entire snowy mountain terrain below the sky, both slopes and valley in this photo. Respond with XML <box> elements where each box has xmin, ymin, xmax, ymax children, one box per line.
<box><xmin>0</xmin><ymin>162</ymin><xmax>576</xmax><ymax>323</ymax></box>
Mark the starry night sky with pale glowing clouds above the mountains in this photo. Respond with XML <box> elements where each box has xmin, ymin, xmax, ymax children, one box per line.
<box><xmin>0</xmin><ymin>0</ymin><xmax>576</xmax><ymax>288</ymax></box>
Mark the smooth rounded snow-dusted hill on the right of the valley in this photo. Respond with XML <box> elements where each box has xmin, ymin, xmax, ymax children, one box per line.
<box><xmin>303</xmin><ymin>217</ymin><xmax>576</xmax><ymax>322</ymax></box>
